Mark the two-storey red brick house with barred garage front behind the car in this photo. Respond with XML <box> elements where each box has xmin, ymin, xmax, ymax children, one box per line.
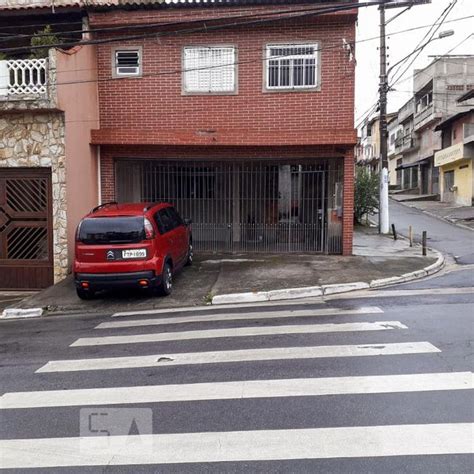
<box><xmin>89</xmin><ymin>0</ymin><xmax>357</xmax><ymax>255</ymax></box>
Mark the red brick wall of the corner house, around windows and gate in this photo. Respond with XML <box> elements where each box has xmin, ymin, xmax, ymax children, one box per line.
<box><xmin>91</xmin><ymin>5</ymin><xmax>356</xmax><ymax>255</ymax></box>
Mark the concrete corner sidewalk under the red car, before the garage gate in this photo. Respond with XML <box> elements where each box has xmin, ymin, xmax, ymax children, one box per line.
<box><xmin>0</xmin><ymin>228</ymin><xmax>439</xmax><ymax>314</ymax></box>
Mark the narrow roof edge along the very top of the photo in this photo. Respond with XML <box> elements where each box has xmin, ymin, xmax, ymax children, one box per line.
<box><xmin>0</xmin><ymin>0</ymin><xmax>353</xmax><ymax>10</ymax></box>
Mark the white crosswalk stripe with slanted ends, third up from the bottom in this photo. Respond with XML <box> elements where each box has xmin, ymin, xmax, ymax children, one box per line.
<box><xmin>36</xmin><ymin>341</ymin><xmax>441</xmax><ymax>372</ymax></box>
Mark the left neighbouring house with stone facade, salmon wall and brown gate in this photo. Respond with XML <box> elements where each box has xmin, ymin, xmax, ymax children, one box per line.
<box><xmin>0</xmin><ymin>2</ymin><xmax>98</xmax><ymax>289</ymax></box>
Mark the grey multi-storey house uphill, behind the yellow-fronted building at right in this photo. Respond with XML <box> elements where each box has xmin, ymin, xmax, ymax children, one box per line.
<box><xmin>397</xmin><ymin>55</ymin><xmax>474</xmax><ymax>195</ymax></box>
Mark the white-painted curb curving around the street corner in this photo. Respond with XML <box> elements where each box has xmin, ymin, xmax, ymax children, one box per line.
<box><xmin>212</xmin><ymin>249</ymin><xmax>445</xmax><ymax>305</ymax></box>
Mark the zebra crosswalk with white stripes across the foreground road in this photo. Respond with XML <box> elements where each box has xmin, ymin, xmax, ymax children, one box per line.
<box><xmin>0</xmin><ymin>305</ymin><xmax>474</xmax><ymax>472</ymax></box>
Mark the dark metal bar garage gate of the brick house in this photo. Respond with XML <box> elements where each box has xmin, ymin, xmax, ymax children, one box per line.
<box><xmin>116</xmin><ymin>159</ymin><xmax>342</xmax><ymax>253</ymax></box>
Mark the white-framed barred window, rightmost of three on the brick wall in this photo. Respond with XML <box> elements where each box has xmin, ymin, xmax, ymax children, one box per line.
<box><xmin>265</xmin><ymin>44</ymin><xmax>319</xmax><ymax>90</ymax></box>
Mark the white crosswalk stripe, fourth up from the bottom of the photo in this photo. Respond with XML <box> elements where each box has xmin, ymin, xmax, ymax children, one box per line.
<box><xmin>70</xmin><ymin>321</ymin><xmax>408</xmax><ymax>347</ymax></box>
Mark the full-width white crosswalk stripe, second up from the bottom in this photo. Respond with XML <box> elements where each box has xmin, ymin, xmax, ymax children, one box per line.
<box><xmin>0</xmin><ymin>372</ymin><xmax>474</xmax><ymax>410</ymax></box>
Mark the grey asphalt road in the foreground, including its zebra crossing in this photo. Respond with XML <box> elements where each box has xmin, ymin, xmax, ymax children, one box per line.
<box><xmin>0</xmin><ymin>203</ymin><xmax>474</xmax><ymax>473</ymax></box>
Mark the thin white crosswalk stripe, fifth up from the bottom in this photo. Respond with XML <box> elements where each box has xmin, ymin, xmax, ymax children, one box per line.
<box><xmin>95</xmin><ymin>306</ymin><xmax>383</xmax><ymax>329</ymax></box>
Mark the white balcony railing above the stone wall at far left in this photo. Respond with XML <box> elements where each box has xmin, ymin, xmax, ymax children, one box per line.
<box><xmin>0</xmin><ymin>58</ymin><xmax>48</xmax><ymax>99</ymax></box>
